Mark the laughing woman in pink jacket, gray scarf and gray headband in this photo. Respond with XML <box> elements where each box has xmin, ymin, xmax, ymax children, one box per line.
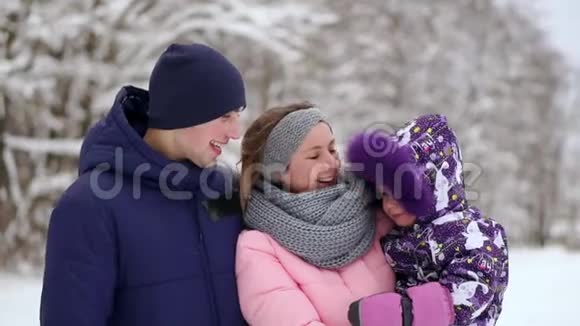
<box><xmin>236</xmin><ymin>104</ymin><xmax>395</xmax><ymax>326</ymax></box>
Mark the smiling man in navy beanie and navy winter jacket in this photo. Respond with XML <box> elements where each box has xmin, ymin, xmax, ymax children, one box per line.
<box><xmin>40</xmin><ymin>44</ymin><xmax>246</xmax><ymax>326</ymax></box>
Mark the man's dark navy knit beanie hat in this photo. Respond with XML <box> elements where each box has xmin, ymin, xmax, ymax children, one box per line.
<box><xmin>149</xmin><ymin>44</ymin><xmax>246</xmax><ymax>129</ymax></box>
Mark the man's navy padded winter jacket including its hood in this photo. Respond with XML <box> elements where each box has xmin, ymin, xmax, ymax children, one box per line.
<box><xmin>40</xmin><ymin>87</ymin><xmax>244</xmax><ymax>326</ymax></box>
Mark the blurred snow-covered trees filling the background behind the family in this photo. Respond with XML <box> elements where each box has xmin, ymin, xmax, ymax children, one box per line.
<box><xmin>0</xmin><ymin>0</ymin><xmax>580</xmax><ymax>272</ymax></box>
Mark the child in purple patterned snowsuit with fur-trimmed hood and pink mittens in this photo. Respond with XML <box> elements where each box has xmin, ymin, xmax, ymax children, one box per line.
<box><xmin>347</xmin><ymin>115</ymin><xmax>508</xmax><ymax>326</ymax></box>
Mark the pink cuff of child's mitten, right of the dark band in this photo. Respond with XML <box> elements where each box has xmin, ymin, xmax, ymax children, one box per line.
<box><xmin>407</xmin><ymin>282</ymin><xmax>455</xmax><ymax>326</ymax></box>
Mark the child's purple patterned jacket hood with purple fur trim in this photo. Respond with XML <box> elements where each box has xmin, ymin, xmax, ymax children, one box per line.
<box><xmin>347</xmin><ymin>114</ymin><xmax>467</xmax><ymax>223</ymax></box>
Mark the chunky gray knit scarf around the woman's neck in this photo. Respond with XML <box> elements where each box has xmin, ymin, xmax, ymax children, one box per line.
<box><xmin>244</xmin><ymin>177</ymin><xmax>375</xmax><ymax>269</ymax></box>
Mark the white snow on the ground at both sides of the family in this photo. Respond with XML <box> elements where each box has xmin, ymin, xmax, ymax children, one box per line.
<box><xmin>0</xmin><ymin>248</ymin><xmax>580</xmax><ymax>326</ymax></box>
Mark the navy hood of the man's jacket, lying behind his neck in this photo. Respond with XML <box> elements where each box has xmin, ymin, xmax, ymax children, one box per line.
<box><xmin>79</xmin><ymin>86</ymin><xmax>229</xmax><ymax>195</ymax></box>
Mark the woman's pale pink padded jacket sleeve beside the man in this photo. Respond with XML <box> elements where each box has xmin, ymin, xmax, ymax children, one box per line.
<box><xmin>236</xmin><ymin>231</ymin><xmax>324</xmax><ymax>326</ymax></box>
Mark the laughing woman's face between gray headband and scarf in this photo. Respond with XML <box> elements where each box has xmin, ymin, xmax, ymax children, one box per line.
<box><xmin>281</xmin><ymin>122</ymin><xmax>340</xmax><ymax>193</ymax></box>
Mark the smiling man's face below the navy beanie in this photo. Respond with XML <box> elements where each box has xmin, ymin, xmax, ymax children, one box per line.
<box><xmin>175</xmin><ymin>110</ymin><xmax>241</xmax><ymax>168</ymax></box>
